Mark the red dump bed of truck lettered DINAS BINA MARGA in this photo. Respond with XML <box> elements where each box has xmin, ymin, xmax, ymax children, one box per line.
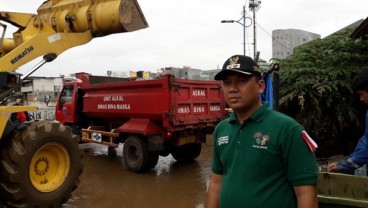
<box><xmin>83</xmin><ymin>76</ymin><xmax>225</xmax><ymax>129</ymax></box>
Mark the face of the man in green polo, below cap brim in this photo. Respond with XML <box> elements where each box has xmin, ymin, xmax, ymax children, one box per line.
<box><xmin>222</xmin><ymin>73</ymin><xmax>265</xmax><ymax>112</ymax></box>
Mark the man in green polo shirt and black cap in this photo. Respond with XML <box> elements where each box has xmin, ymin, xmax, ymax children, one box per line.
<box><xmin>208</xmin><ymin>55</ymin><xmax>318</xmax><ymax>208</ymax></box>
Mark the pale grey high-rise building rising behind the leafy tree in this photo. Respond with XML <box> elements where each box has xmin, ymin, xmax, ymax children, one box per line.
<box><xmin>272</xmin><ymin>29</ymin><xmax>321</xmax><ymax>59</ymax></box>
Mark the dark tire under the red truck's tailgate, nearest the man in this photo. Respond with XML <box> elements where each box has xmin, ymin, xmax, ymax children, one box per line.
<box><xmin>171</xmin><ymin>143</ymin><xmax>202</xmax><ymax>162</ymax></box>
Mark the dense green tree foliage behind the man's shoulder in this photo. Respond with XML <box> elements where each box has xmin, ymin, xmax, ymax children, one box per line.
<box><xmin>279</xmin><ymin>30</ymin><xmax>368</xmax><ymax>153</ymax></box>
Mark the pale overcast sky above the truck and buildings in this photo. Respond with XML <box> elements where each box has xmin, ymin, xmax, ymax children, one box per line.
<box><xmin>0</xmin><ymin>0</ymin><xmax>368</xmax><ymax>76</ymax></box>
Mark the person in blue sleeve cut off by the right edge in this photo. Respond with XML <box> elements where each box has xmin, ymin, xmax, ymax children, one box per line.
<box><xmin>327</xmin><ymin>70</ymin><xmax>368</xmax><ymax>174</ymax></box>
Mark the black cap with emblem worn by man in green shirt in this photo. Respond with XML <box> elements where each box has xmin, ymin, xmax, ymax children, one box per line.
<box><xmin>215</xmin><ymin>55</ymin><xmax>262</xmax><ymax>80</ymax></box>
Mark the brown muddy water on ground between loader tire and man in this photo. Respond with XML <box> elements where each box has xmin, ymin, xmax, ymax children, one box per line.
<box><xmin>63</xmin><ymin>136</ymin><xmax>212</xmax><ymax>208</ymax></box>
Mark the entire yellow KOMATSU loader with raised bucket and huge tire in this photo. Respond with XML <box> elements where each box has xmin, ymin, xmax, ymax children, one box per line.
<box><xmin>0</xmin><ymin>0</ymin><xmax>148</xmax><ymax>207</ymax></box>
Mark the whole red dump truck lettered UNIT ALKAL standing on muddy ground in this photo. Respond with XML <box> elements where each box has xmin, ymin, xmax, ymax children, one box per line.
<box><xmin>55</xmin><ymin>73</ymin><xmax>226</xmax><ymax>172</ymax></box>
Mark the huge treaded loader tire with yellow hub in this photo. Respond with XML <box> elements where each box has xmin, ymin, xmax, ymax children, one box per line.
<box><xmin>0</xmin><ymin>121</ymin><xmax>83</xmax><ymax>207</ymax></box>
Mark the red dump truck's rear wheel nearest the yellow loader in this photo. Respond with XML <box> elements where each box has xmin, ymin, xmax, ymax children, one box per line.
<box><xmin>123</xmin><ymin>136</ymin><xmax>150</xmax><ymax>172</ymax></box>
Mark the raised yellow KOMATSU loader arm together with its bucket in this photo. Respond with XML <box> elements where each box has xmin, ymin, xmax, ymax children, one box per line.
<box><xmin>0</xmin><ymin>0</ymin><xmax>148</xmax><ymax>72</ymax></box>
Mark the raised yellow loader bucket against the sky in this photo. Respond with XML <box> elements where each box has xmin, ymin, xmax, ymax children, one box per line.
<box><xmin>37</xmin><ymin>0</ymin><xmax>148</xmax><ymax>37</ymax></box>
